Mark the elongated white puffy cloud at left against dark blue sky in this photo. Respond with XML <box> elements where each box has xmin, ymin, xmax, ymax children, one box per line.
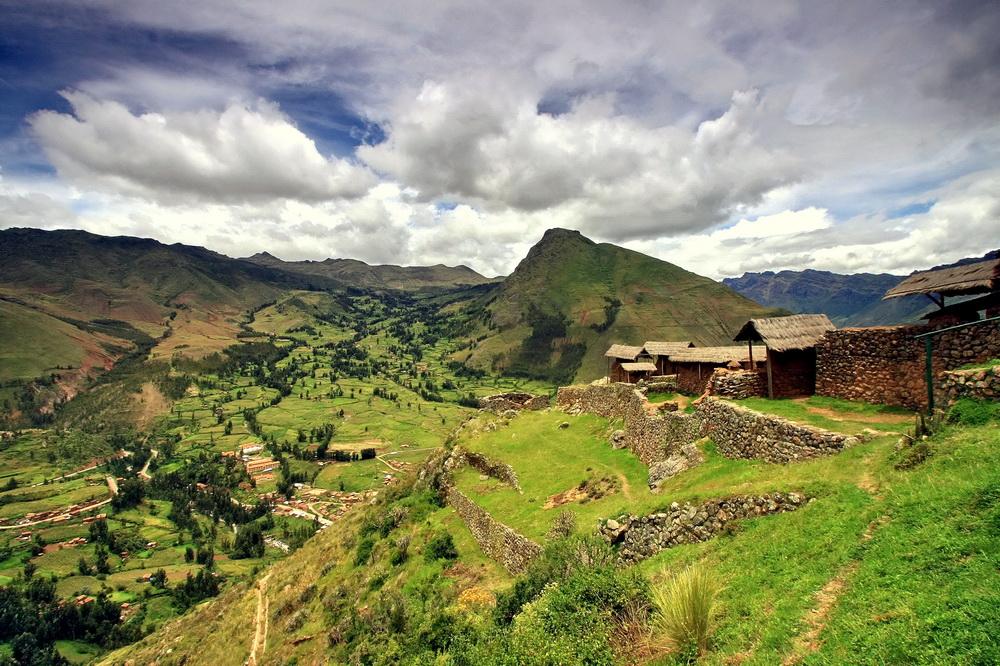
<box><xmin>30</xmin><ymin>92</ymin><xmax>376</xmax><ymax>202</ymax></box>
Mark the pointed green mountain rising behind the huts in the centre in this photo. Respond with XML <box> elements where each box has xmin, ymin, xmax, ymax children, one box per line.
<box><xmin>458</xmin><ymin>229</ymin><xmax>782</xmax><ymax>382</ymax></box>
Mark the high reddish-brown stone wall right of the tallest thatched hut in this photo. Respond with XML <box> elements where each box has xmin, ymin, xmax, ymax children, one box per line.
<box><xmin>816</xmin><ymin>322</ymin><xmax>1000</xmax><ymax>409</ymax></box>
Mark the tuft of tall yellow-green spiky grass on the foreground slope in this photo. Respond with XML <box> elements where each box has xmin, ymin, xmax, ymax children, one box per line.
<box><xmin>653</xmin><ymin>565</ymin><xmax>722</xmax><ymax>659</ymax></box>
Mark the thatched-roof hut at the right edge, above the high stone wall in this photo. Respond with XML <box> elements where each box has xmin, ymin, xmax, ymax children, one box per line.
<box><xmin>882</xmin><ymin>251</ymin><xmax>1000</xmax><ymax>324</ymax></box>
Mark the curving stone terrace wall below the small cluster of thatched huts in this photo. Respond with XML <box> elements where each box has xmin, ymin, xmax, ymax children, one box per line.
<box><xmin>556</xmin><ymin>384</ymin><xmax>701</xmax><ymax>465</ymax></box>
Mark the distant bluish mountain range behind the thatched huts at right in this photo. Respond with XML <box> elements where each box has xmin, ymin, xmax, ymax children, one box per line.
<box><xmin>722</xmin><ymin>251</ymin><xmax>997</xmax><ymax>328</ymax></box>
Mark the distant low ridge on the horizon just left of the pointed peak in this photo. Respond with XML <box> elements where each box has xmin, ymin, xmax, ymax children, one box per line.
<box><xmin>246</xmin><ymin>252</ymin><xmax>501</xmax><ymax>290</ymax></box>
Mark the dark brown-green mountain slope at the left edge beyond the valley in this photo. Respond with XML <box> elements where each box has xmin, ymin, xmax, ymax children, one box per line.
<box><xmin>0</xmin><ymin>228</ymin><xmax>340</xmax><ymax>380</ymax></box>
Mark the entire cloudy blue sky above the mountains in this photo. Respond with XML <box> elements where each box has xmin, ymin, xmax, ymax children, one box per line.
<box><xmin>0</xmin><ymin>0</ymin><xmax>1000</xmax><ymax>279</ymax></box>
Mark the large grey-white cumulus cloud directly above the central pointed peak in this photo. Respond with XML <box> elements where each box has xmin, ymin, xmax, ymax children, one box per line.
<box><xmin>358</xmin><ymin>82</ymin><xmax>797</xmax><ymax>240</ymax></box>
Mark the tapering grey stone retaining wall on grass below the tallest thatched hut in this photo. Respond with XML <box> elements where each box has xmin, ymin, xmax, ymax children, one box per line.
<box><xmin>697</xmin><ymin>397</ymin><xmax>858</xmax><ymax>463</ymax></box>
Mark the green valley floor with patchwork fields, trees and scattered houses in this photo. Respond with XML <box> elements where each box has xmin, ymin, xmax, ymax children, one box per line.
<box><xmin>0</xmin><ymin>292</ymin><xmax>554</xmax><ymax>663</ymax></box>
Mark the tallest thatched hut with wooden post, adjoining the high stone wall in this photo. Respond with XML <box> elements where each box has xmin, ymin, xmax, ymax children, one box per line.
<box><xmin>733</xmin><ymin>314</ymin><xmax>836</xmax><ymax>398</ymax></box>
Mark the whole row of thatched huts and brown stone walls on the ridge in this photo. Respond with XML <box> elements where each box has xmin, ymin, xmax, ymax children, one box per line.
<box><xmin>605</xmin><ymin>259</ymin><xmax>1000</xmax><ymax>412</ymax></box>
